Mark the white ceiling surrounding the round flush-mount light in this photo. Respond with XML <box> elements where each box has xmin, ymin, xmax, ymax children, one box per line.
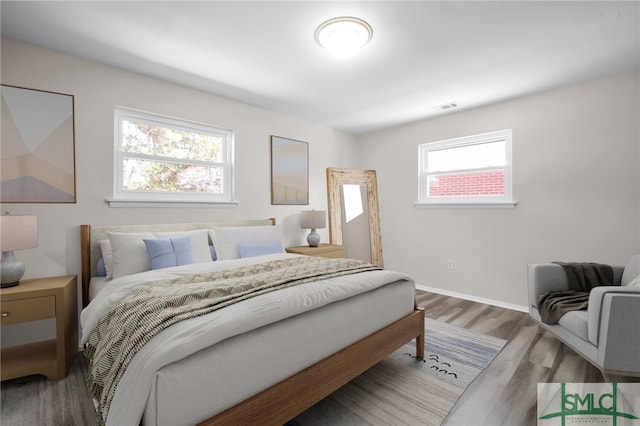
<box><xmin>0</xmin><ymin>0</ymin><xmax>640</xmax><ymax>134</ymax></box>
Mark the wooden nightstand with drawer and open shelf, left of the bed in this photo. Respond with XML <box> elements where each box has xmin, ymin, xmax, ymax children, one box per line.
<box><xmin>0</xmin><ymin>275</ymin><xmax>78</xmax><ymax>380</ymax></box>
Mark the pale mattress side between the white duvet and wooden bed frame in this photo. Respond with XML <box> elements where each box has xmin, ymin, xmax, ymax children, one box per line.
<box><xmin>143</xmin><ymin>281</ymin><xmax>415</xmax><ymax>426</ymax></box>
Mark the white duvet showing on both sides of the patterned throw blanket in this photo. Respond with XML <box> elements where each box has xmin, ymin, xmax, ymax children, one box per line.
<box><xmin>80</xmin><ymin>253</ymin><xmax>411</xmax><ymax>425</ymax></box>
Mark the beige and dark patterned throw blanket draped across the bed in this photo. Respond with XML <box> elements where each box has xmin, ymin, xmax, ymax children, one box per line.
<box><xmin>84</xmin><ymin>256</ymin><xmax>381</xmax><ymax>424</ymax></box>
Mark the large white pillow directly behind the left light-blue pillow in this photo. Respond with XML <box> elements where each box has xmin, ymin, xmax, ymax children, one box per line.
<box><xmin>105</xmin><ymin>229</ymin><xmax>211</xmax><ymax>278</ymax></box>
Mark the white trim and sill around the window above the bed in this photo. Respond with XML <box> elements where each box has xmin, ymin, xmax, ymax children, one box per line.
<box><xmin>106</xmin><ymin>107</ymin><xmax>237</xmax><ymax>207</ymax></box>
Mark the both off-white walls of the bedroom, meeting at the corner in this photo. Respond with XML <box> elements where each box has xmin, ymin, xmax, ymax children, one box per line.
<box><xmin>1</xmin><ymin>38</ymin><xmax>640</xmax><ymax>312</ymax></box>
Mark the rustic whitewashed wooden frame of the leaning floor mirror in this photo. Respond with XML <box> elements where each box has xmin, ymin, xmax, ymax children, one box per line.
<box><xmin>327</xmin><ymin>167</ymin><xmax>384</xmax><ymax>267</ymax></box>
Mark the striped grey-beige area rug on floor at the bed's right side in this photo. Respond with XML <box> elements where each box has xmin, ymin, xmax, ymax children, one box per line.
<box><xmin>287</xmin><ymin>318</ymin><xmax>507</xmax><ymax>426</ymax></box>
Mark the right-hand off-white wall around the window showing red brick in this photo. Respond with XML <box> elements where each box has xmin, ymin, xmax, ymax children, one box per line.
<box><xmin>360</xmin><ymin>75</ymin><xmax>640</xmax><ymax>306</ymax></box>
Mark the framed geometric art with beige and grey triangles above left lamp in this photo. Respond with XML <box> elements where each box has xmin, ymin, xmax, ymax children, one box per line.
<box><xmin>0</xmin><ymin>84</ymin><xmax>76</xmax><ymax>203</ymax></box>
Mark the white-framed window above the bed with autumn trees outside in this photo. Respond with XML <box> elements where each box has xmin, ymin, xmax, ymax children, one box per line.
<box><xmin>114</xmin><ymin>109</ymin><xmax>233</xmax><ymax>203</ymax></box>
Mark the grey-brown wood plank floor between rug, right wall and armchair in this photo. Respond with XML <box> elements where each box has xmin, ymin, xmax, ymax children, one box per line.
<box><xmin>418</xmin><ymin>290</ymin><xmax>638</xmax><ymax>426</ymax></box>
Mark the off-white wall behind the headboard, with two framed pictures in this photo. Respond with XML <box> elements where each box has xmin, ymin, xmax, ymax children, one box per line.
<box><xmin>1</xmin><ymin>37</ymin><xmax>357</xmax><ymax>286</ymax></box>
